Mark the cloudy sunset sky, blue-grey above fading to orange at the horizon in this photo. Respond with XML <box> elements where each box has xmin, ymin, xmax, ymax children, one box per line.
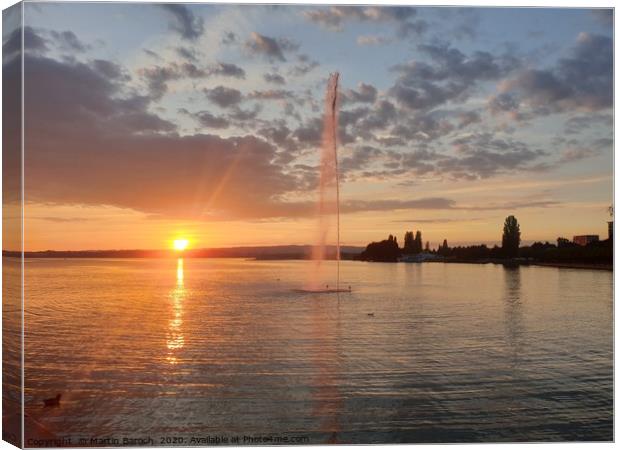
<box><xmin>3</xmin><ymin>2</ymin><xmax>613</xmax><ymax>250</ymax></box>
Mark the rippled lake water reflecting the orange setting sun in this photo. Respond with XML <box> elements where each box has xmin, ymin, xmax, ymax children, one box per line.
<box><xmin>14</xmin><ymin>259</ymin><xmax>613</xmax><ymax>445</ymax></box>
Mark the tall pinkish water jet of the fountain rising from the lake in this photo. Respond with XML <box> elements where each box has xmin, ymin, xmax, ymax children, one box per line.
<box><xmin>310</xmin><ymin>72</ymin><xmax>340</xmax><ymax>291</ymax></box>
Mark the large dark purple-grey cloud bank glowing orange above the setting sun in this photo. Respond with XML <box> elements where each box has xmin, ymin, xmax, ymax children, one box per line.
<box><xmin>18</xmin><ymin>51</ymin><xmax>313</xmax><ymax>220</ymax></box>
